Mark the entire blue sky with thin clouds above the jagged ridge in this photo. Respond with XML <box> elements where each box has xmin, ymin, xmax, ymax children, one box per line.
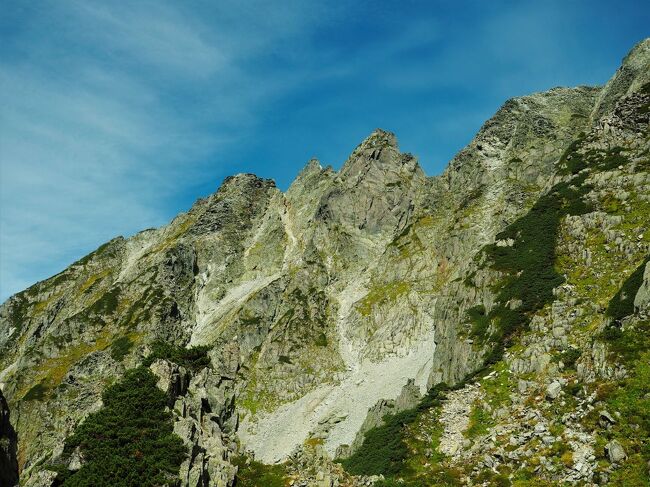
<box><xmin>0</xmin><ymin>0</ymin><xmax>650</xmax><ymax>300</ymax></box>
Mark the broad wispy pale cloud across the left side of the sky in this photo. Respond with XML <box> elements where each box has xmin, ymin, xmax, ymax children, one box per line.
<box><xmin>0</xmin><ymin>1</ymin><xmax>332</xmax><ymax>299</ymax></box>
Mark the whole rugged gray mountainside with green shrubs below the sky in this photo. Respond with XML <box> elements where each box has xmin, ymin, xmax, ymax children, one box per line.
<box><xmin>0</xmin><ymin>40</ymin><xmax>650</xmax><ymax>487</ymax></box>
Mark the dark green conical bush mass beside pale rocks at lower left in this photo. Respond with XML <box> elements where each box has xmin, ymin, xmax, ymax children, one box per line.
<box><xmin>54</xmin><ymin>367</ymin><xmax>187</xmax><ymax>487</ymax></box>
